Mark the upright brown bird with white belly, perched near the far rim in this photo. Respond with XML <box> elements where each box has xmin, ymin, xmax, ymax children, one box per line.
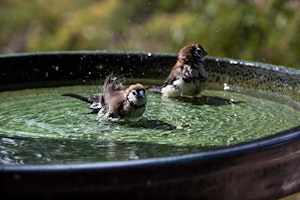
<box><xmin>160</xmin><ymin>43</ymin><xmax>207</xmax><ymax>97</ymax></box>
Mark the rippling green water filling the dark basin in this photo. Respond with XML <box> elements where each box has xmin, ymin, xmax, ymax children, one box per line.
<box><xmin>0</xmin><ymin>85</ymin><xmax>300</xmax><ymax>165</ymax></box>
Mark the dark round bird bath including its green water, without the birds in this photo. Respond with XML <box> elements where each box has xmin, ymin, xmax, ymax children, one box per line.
<box><xmin>0</xmin><ymin>51</ymin><xmax>300</xmax><ymax>199</ymax></box>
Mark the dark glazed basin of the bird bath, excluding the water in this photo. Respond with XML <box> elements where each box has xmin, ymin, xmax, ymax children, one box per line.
<box><xmin>0</xmin><ymin>51</ymin><xmax>300</xmax><ymax>199</ymax></box>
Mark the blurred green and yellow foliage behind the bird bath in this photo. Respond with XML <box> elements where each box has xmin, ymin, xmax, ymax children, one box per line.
<box><xmin>0</xmin><ymin>0</ymin><xmax>300</xmax><ymax>69</ymax></box>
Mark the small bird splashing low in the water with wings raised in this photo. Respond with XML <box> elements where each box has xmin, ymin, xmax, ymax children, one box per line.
<box><xmin>62</xmin><ymin>75</ymin><xmax>147</xmax><ymax>118</ymax></box>
